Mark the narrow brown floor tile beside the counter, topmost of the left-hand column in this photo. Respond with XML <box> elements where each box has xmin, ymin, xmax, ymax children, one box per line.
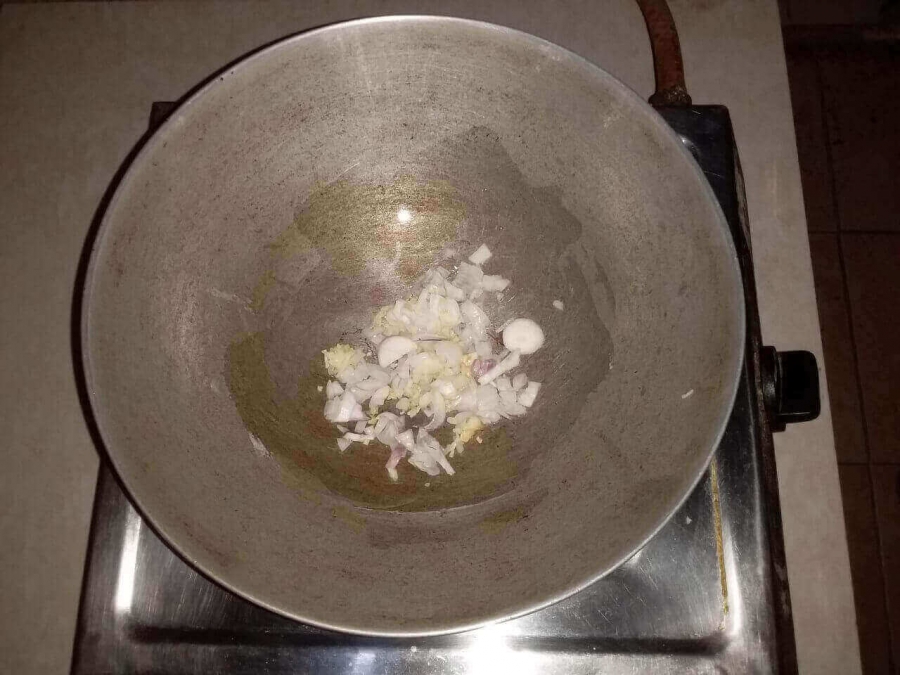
<box><xmin>786</xmin><ymin>49</ymin><xmax>837</xmax><ymax>232</ymax></box>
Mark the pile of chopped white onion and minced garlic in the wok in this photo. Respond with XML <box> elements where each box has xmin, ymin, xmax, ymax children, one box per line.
<box><xmin>319</xmin><ymin>245</ymin><xmax>544</xmax><ymax>481</ymax></box>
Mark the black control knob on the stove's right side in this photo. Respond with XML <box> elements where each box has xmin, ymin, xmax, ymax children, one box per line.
<box><xmin>760</xmin><ymin>347</ymin><xmax>821</xmax><ymax>431</ymax></box>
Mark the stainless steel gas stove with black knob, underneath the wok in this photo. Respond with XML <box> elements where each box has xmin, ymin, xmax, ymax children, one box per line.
<box><xmin>72</xmin><ymin>103</ymin><xmax>818</xmax><ymax>675</ymax></box>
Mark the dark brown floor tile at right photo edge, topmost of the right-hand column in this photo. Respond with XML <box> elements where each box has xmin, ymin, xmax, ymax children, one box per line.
<box><xmin>819</xmin><ymin>49</ymin><xmax>900</xmax><ymax>231</ymax></box>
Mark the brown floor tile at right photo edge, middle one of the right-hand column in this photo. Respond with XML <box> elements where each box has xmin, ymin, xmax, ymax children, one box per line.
<box><xmin>841</xmin><ymin>234</ymin><xmax>900</xmax><ymax>462</ymax></box>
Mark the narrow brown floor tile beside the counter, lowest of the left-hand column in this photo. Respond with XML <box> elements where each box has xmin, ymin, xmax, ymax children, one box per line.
<box><xmin>840</xmin><ymin>464</ymin><xmax>900</xmax><ymax>675</ymax></box>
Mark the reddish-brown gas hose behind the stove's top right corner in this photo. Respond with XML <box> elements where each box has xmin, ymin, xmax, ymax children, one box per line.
<box><xmin>637</xmin><ymin>0</ymin><xmax>691</xmax><ymax>108</ymax></box>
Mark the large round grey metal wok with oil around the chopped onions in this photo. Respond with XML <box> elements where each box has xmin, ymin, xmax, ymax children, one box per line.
<box><xmin>82</xmin><ymin>17</ymin><xmax>744</xmax><ymax>635</ymax></box>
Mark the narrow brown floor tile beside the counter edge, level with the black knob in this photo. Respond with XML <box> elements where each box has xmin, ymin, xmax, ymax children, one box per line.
<box><xmin>809</xmin><ymin>233</ymin><xmax>868</xmax><ymax>462</ymax></box>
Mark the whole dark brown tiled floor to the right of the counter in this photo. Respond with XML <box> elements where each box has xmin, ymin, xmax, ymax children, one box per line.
<box><xmin>783</xmin><ymin>34</ymin><xmax>900</xmax><ymax>675</ymax></box>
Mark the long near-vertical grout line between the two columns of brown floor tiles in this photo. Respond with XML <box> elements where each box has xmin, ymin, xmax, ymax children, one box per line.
<box><xmin>814</xmin><ymin>56</ymin><xmax>894</xmax><ymax>662</ymax></box>
